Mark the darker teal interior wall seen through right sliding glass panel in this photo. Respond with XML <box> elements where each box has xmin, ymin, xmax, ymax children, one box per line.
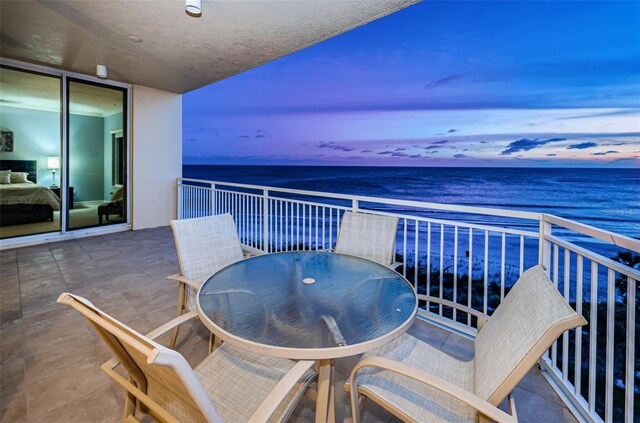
<box><xmin>69</xmin><ymin>114</ymin><xmax>104</xmax><ymax>201</ymax></box>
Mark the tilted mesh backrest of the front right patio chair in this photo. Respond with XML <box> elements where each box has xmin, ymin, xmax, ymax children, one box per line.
<box><xmin>474</xmin><ymin>266</ymin><xmax>587</xmax><ymax>406</ymax></box>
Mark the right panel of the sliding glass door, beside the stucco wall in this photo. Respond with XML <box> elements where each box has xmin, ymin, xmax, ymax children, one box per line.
<box><xmin>67</xmin><ymin>78</ymin><xmax>127</xmax><ymax>230</ymax></box>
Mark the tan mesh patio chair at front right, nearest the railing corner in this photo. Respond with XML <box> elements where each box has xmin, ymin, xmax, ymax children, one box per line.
<box><xmin>345</xmin><ymin>266</ymin><xmax>587</xmax><ymax>423</ymax></box>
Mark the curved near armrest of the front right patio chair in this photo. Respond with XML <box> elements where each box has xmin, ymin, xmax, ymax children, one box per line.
<box><xmin>349</xmin><ymin>357</ymin><xmax>518</xmax><ymax>423</ymax></box>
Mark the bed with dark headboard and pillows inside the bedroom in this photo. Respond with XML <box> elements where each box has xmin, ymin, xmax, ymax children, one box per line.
<box><xmin>0</xmin><ymin>160</ymin><xmax>60</xmax><ymax>226</ymax></box>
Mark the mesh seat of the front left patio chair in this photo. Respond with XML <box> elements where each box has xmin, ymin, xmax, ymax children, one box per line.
<box><xmin>194</xmin><ymin>342</ymin><xmax>317</xmax><ymax>423</ymax></box>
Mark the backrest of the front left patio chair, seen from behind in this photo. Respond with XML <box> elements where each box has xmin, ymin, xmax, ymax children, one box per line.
<box><xmin>58</xmin><ymin>293</ymin><xmax>222</xmax><ymax>422</ymax></box>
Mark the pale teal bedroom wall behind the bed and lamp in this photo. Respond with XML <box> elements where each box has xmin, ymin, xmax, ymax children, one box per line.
<box><xmin>0</xmin><ymin>105</ymin><xmax>60</xmax><ymax>187</ymax></box>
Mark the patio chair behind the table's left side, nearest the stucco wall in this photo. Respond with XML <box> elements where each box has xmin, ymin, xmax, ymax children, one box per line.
<box><xmin>167</xmin><ymin>213</ymin><xmax>250</xmax><ymax>348</ymax></box>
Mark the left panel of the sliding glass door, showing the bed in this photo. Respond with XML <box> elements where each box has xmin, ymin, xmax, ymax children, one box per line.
<box><xmin>0</xmin><ymin>66</ymin><xmax>65</xmax><ymax>239</ymax></box>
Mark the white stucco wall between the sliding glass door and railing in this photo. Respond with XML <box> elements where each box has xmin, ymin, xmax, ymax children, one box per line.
<box><xmin>131</xmin><ymin>85</ymin><xmax>182</xmax><ymax>230</ymax></box>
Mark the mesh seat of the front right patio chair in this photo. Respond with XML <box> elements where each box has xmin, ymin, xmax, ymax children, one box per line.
<box><xmin>356</xmin><ymin>334</ymin><xmax>477</xmax><ymax>422</ymax></box>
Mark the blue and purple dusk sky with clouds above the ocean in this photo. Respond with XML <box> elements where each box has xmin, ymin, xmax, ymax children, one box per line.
<box><xmin>183</xmin><ymin>1</ymin><xmax>640</xmax><ymax>167</ymax></box>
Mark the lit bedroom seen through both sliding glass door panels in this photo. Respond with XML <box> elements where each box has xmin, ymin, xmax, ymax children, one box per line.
<box><xmin>0</xmin><ymin>68</ymin><xmax>126</xmax><ymax>239</ymax></box>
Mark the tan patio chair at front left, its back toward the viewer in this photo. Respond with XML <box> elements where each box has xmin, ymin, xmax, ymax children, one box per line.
<box><xmin>58</xmin><ymin>293</ymin><xmax>317</xmax><ymax>423</ymax></box>
